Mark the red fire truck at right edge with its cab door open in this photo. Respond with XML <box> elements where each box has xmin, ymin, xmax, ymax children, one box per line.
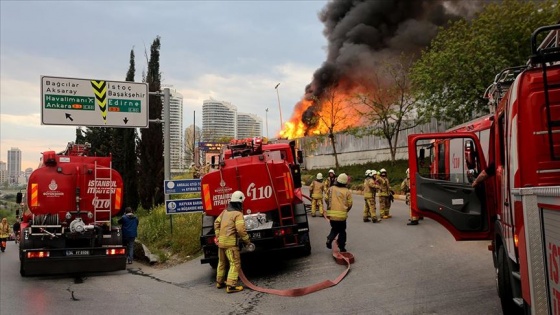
<box><xmin>408</xmin><ymin>25</ymin><xmax>560</xmax><ymax>314</ymax></box>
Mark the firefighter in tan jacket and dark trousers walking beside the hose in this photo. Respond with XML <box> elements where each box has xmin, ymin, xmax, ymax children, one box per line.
<box><xmin>327</xmin><ymin>173</ymin><xmax>352</xmax><ymax>252</ymax></box>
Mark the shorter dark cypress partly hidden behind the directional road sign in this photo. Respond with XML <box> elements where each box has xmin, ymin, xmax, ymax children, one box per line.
<box><xmin>113</xmin><ymin>49</ymin><xmax>139</xmax><ymax>209</ymax></box>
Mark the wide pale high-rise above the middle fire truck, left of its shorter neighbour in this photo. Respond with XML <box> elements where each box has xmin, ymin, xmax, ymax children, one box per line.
<box><xmin>202</xmin><ymin>98</ymin><xmax>237</xmax><ymax>141</ymax></box>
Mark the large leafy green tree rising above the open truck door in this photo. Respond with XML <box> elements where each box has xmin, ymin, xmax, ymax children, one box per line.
<box><xmin>411</xmin><ymin>0</ymin><xmax>560</xmax><ymax>124</ymax></box>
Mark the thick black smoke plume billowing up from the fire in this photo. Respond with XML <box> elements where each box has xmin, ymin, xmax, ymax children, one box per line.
<box><xmin>296</xmin><ymin>0</ymin><xmax>493</xmax><ymax>130</ymax></box>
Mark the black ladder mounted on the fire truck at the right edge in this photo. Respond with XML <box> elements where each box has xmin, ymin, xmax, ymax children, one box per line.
<box><xmin>529</xmin><ymin>24</ymin><xmax>560</xmax><ymax>160</ymax></box>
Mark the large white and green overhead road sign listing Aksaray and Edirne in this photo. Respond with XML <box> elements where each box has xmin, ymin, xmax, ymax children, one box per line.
<box><xmin>41</xmin><ymin>76</ymin><xmax>149</xmax><ymax>128</ymax></box>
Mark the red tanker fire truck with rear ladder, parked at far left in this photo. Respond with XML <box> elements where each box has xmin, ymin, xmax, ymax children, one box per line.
<box><xmin>18</xmin><ymin>143</ymin><xmax>126</xmax><ymax>276</ymax></box>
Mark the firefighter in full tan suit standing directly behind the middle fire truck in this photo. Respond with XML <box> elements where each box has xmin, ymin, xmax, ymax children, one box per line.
<box><xmin>214</xmin><ymin>191</ymin><xmax>251</xmax><ymax>293</ymax></box>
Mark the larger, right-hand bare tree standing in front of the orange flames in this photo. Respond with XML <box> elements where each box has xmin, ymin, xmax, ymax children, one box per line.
<box><xmin>354</xmin><ymin>54</ymin><xmax>418</xmax><ymax>163</ymax></box>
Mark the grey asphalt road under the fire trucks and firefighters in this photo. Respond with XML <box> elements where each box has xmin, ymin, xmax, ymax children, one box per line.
<box><xmin>0</xmin><ymin>195</ymin><xmax>501</xmax><ymax>315</ymax></box>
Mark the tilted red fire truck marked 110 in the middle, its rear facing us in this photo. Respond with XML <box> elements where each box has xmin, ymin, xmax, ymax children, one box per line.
<box><xmin>200</xmin><ymin>138</ymin><xmax>311</xmax><ymax>268</ymax></box>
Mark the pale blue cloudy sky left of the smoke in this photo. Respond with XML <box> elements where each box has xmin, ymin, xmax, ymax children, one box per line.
<box><xmin>0</xmin><ymin>0</ymin><xmax>327</xmax><ymax>170</ymax></box>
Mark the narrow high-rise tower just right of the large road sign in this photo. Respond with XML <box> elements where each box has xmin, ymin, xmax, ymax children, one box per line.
<box><xmin>162</xmin><ymin>88</ymin><xmax>186</xmax><ymax>173</ymax></box>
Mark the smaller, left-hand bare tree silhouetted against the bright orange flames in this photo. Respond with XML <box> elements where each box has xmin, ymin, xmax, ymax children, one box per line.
<box><xmin>310</xmin><ymin>84</ymin><xmax>352</xmax><ymax>171</ymax></box>
